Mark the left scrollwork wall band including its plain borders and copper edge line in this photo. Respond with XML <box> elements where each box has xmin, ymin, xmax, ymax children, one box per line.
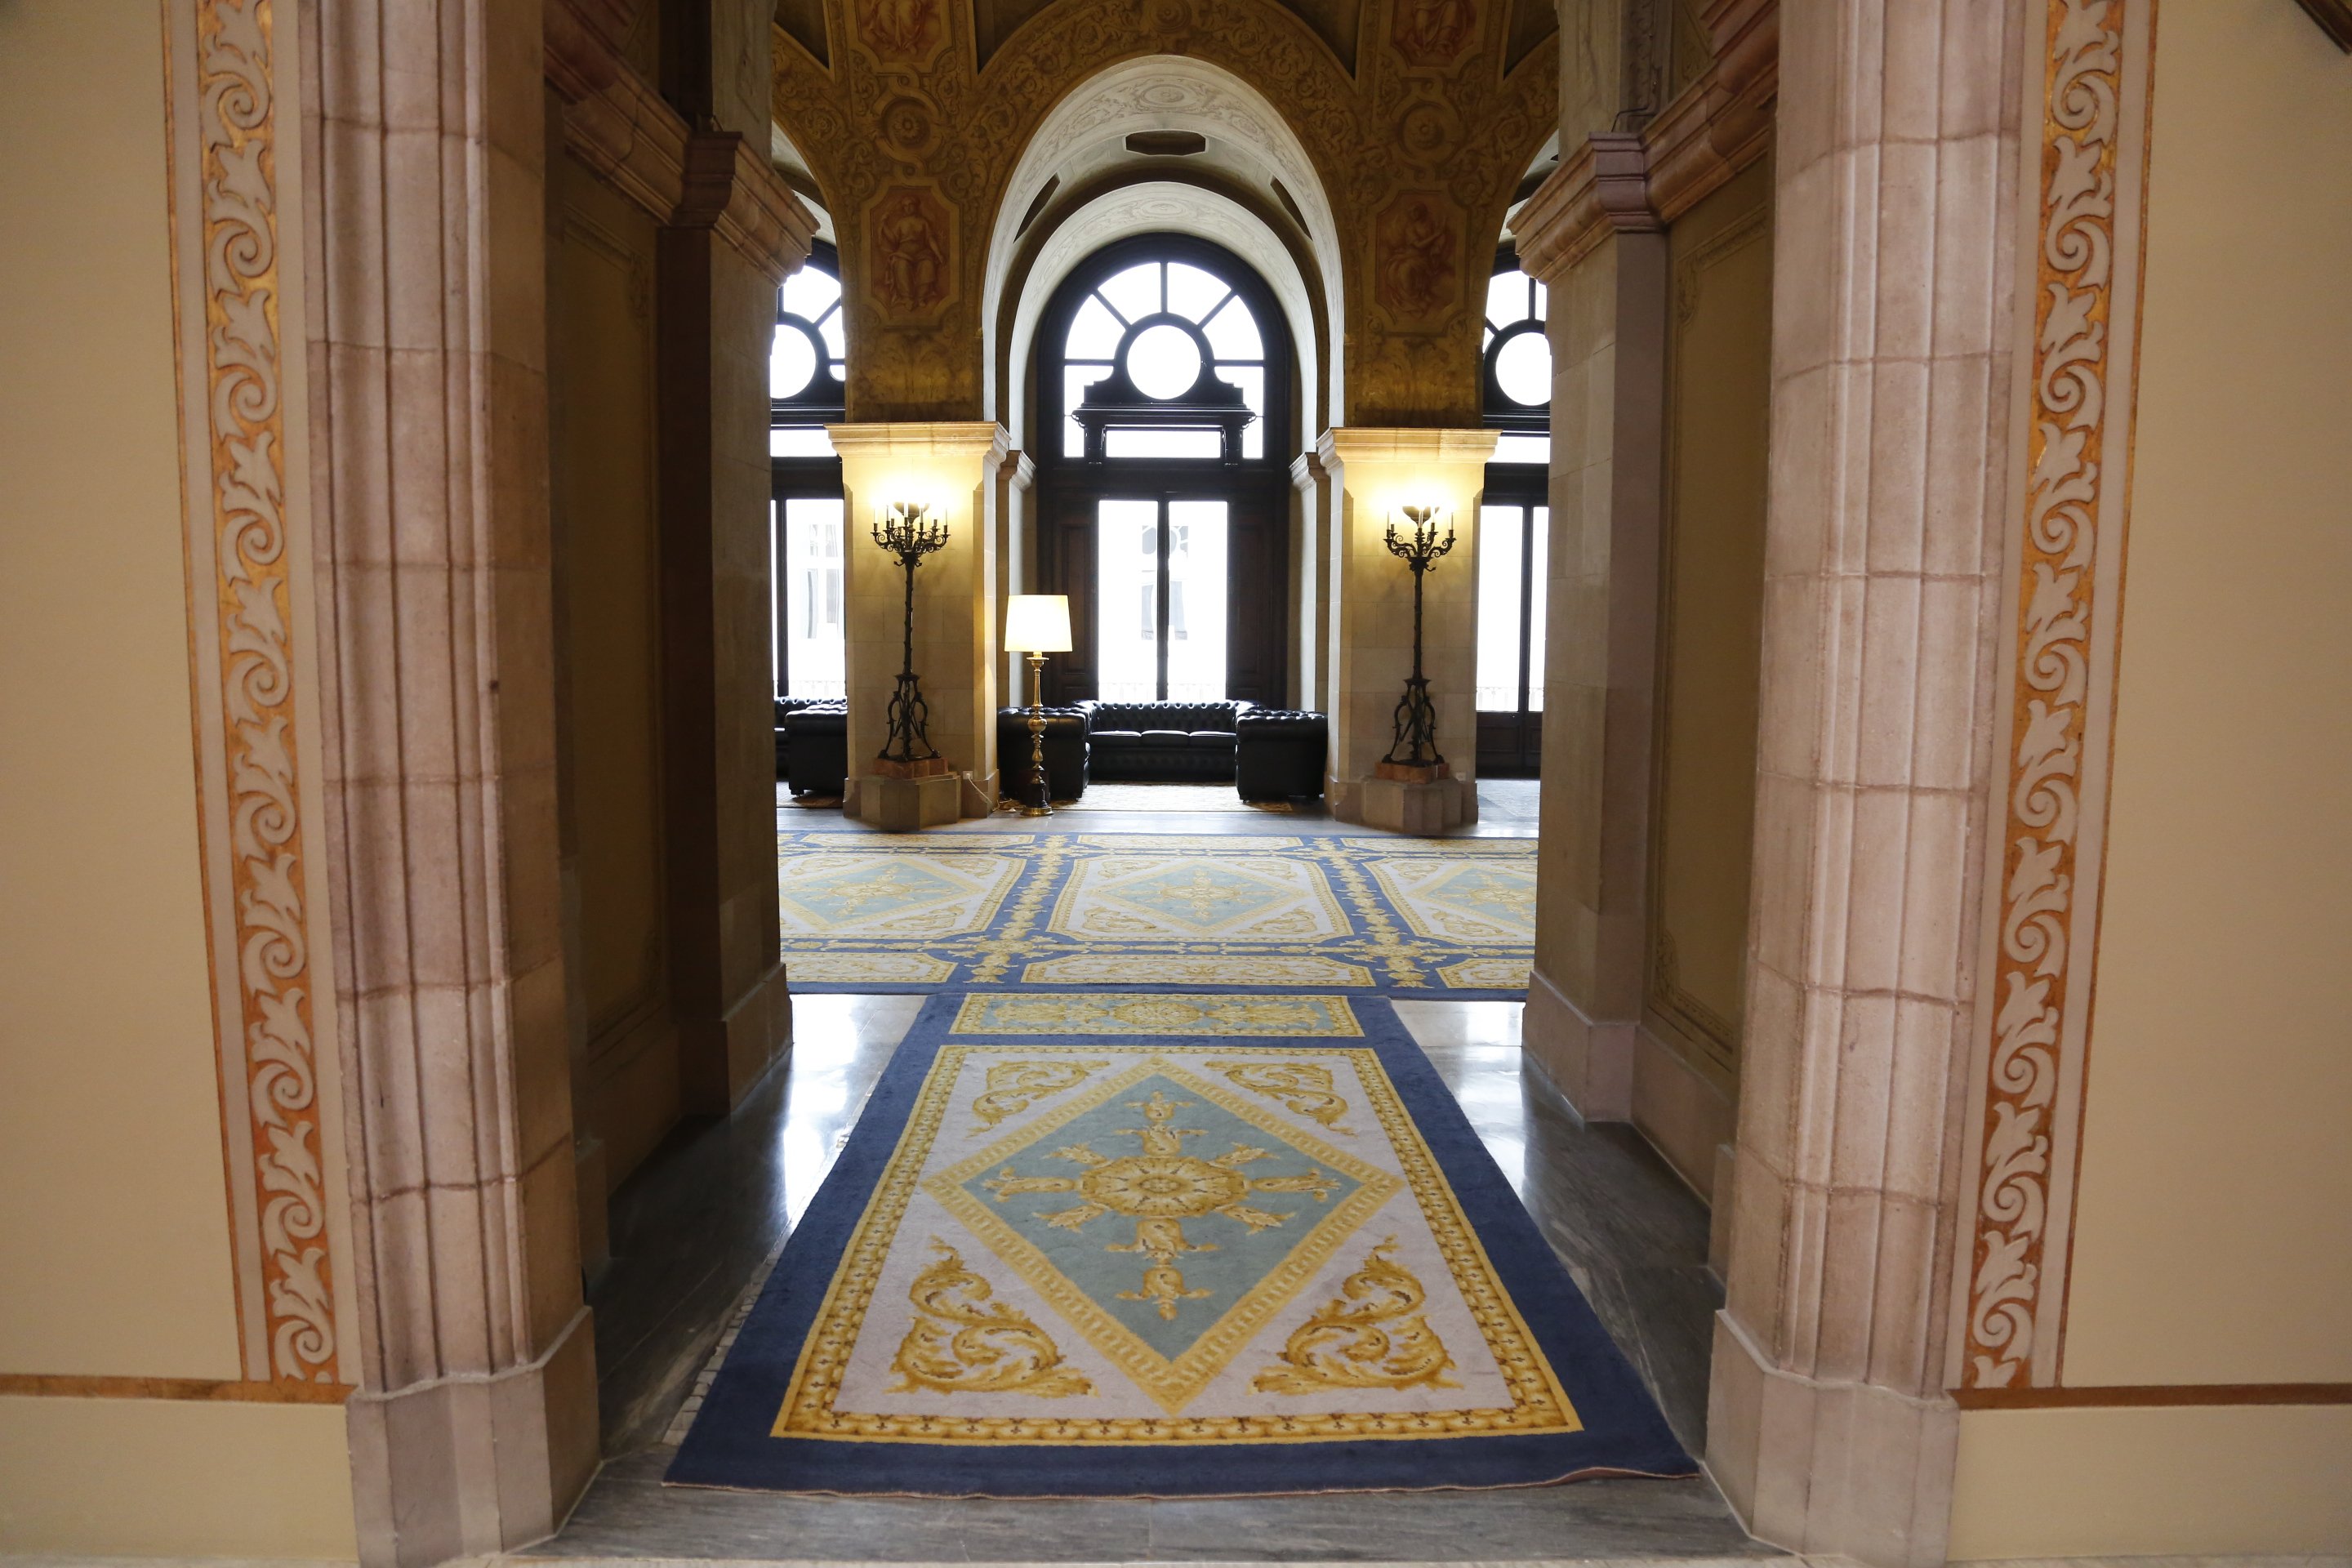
<box><xmin>172</xmin><ymin>0</ymin><xmax>343</xmax><ymax>1384</ymax></box>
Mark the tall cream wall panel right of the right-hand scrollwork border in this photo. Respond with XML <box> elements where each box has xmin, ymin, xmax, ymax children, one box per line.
<box><xmin>2060</xmin><ymin>0</ymin><xmax>2352</xmax><ymax>1382</ymax></box>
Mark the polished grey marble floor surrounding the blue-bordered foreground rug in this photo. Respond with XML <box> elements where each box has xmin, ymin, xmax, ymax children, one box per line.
<box><xmin>550</xmin><ymin>982</ymin><xmax>1775</xmax><ymax>1563</ymax></box>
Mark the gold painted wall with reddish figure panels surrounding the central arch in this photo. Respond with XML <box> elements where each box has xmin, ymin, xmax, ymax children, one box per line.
<box><xmin>774</xmin><ymin>0</ymin><xmax>1559</xmax><ymax>423</ymax></box>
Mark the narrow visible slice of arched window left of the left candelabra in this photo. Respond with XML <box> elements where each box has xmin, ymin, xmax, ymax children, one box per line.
<box><xmin>767</xmin><ymin>240</ymin><xmax>847</xmax><ymax>698</ymax></box>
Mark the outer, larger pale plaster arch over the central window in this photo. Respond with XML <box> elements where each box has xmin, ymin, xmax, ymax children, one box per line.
<box><xmin>981</xmin><ymin>54</ymin><xmax>1345</xmax><ymax>439</ymax></box>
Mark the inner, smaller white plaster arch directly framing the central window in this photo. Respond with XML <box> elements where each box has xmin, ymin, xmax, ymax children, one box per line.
<box><xmin>990</xmin><ymin>181</ymin><xmax>1339</xmax><ymax>449</ymax></box>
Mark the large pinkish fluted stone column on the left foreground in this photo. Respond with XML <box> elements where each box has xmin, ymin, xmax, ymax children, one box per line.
<box><xmin>308</xmin><ymin>0</ymin><xmax>598</xmax><ymax>1566</ymax></box>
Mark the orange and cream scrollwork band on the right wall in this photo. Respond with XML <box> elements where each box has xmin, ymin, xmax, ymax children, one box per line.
<box><xmin>1948</xmin><ymin>0</ymin><xmax>2154</xmax><ymax>1389</ymax></box>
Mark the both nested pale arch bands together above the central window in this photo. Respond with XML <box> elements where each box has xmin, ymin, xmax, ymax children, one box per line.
<box><xmin>983</xmin><ymin>56</ymin><xmax>1348</xmax><ymax>435</ymax></box>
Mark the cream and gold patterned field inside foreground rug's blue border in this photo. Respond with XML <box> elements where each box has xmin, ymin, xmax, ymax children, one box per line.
<box><xmin>774</xmin><ymin>1044</ymin><xmax>1578</xmax><ymax>1443</ymax></box>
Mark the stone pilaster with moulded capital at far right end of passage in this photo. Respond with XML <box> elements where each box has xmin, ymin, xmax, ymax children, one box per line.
<box><xmin>1519</xmin><ymin>159</ymin><xmax>1668</xmax><ymax>1121</ymax></box>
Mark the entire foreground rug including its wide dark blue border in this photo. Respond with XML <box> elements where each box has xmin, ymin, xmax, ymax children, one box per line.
<box><xmin>668</xmin><ymin>992</ymin><xmax>1694</xmax><ymax>1498</ymax></box>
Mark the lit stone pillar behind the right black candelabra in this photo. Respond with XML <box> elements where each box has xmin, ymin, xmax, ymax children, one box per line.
<box><xmin>1317</xmin><ymin>425</ymin><xmax>1496</xmax><ymax>832</ymax></box>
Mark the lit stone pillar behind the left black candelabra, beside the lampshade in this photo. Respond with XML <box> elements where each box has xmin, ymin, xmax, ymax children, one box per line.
<box><xmin>831</xmin><ymin>421</ymin><xmax>1007</xmax><ymax>830</ymax></box>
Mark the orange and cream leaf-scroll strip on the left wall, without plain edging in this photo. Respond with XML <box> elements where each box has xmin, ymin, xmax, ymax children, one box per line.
<box><xmin>195</xmin><ymin>0</ymin><xmax>336</xmax><ymax>1383</ymax></box>
